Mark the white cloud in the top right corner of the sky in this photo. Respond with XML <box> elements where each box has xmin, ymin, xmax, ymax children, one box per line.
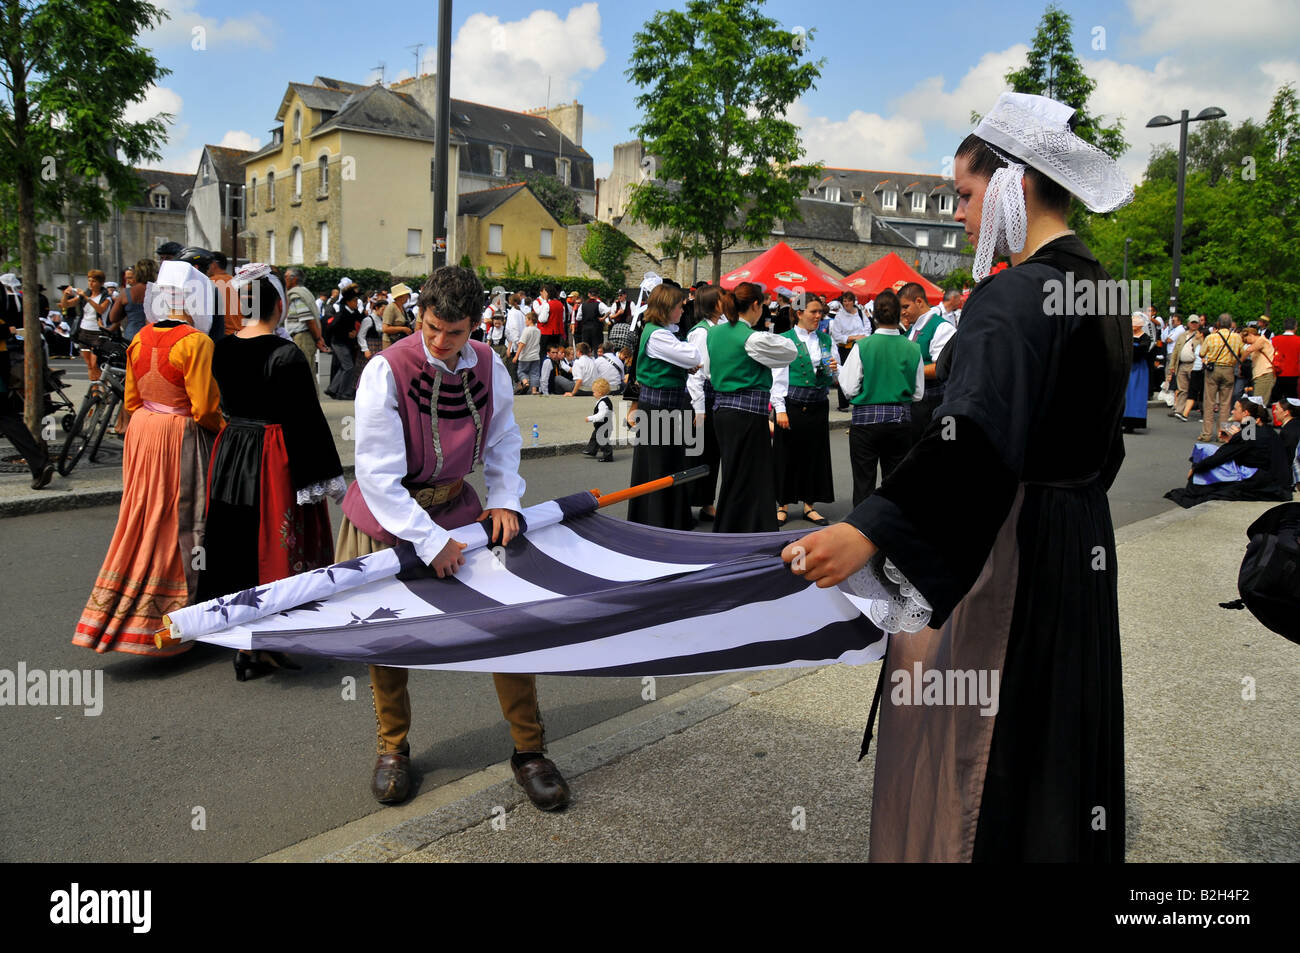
<box><xmin>1128</xmin><ymin>0</ymin><xmax>1300</xmax><ymax>59</ymax></box>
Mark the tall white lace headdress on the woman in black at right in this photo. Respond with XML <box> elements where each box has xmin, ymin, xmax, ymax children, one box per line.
<box><xmin>972</xmin><ymin>92</ymin><xmax>1134</xmax><ymax>281</ymax></box>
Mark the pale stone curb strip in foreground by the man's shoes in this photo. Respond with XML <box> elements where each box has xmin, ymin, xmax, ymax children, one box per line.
<box><xmin>259</xmin><ymin>668</ymin><xmax>820</xmax><ymax>863</ymax></box>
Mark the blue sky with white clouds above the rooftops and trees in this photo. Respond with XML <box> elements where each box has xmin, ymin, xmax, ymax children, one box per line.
<box><xmin>133</xmin><ymin>0</ymin><xmax>1300</xmax><ymax>178</ymax></box>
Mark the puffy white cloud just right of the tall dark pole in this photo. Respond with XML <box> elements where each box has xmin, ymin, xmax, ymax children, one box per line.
<box><xmin>449</xmin><ymin>3</ymin><xmax>605</xmax><ymax>109</ymax></box>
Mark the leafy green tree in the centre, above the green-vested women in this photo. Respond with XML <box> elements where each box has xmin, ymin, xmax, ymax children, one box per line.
<box><xmin>627</xmin><ymin>0</ymin><xmax>823</xmax><ymax>281</ymax></box>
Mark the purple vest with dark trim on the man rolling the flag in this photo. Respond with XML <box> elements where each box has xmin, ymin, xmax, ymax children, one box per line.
<box><xmin>343</xmin><ymin>334</ymin><xmax>495</xmax><ymax>546</ymax></box>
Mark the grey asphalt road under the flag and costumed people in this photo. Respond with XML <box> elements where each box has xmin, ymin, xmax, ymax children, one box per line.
<box><xmin>0</xmin><ymin>407</ymin><xmax>1197</xmax><ymax>861</ymax></box>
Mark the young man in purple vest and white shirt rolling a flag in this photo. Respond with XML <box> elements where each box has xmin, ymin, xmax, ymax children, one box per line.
<box><xmin>335</xmin><ymin>267</ymin><xmax>569</xmax><ymax>810</ymax></box>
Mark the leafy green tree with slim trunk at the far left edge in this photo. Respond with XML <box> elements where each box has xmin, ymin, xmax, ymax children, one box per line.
<box><xmin>0</xmin><ymin>0</ymin><xmax>170</xmax><ymax>438</ymax></box>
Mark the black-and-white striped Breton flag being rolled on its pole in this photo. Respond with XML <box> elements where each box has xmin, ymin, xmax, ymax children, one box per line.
<box><xmin>168</xmin><ymin>493</ymin><xmax>928</xmax><ymax>676</ymax></box>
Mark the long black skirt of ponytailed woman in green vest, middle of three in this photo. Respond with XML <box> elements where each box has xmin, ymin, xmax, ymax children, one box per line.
<box><xmin>712</xmin><ymin>407</ymin><xmax>777</xmax><ymax>533</ymax></box>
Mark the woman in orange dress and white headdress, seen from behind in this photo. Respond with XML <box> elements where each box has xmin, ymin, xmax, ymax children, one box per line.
<box><xmin>73</xmin><ymin>261</ymin><xmax>222</xmax><ymax>655</ymax></box>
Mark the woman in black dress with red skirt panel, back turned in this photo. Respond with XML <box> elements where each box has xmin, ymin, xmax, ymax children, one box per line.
<box><xmin>196</xmin><ymin>263</ymin><xmax>343</xmax><ymax>681</ymax></box>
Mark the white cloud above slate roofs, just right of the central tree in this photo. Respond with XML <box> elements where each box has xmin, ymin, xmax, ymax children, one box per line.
<box><xmin>787</xmin><ymin>100</ymin><xmax>926</xmax><ymax>169</ymax></box>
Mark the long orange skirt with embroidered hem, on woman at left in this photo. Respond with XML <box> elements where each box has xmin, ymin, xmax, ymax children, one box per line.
<box><xmin>73</xmin><ymin>407</ymin><xmax>213</xmax><ymax>657</ymax></box>
